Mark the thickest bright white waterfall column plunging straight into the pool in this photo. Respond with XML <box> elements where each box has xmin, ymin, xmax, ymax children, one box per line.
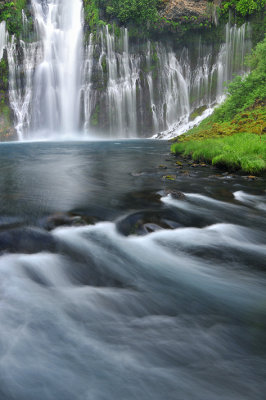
<box><xmin>32</xmin><ymin>0</ymin><xmax>82</xmax><ymax>134</ymax></box>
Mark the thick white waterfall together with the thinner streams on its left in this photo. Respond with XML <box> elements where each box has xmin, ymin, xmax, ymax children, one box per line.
<box><xmin>8</xmin><ymin>0</ymin><xmax>83</xmax><ymax>139</ymax></box>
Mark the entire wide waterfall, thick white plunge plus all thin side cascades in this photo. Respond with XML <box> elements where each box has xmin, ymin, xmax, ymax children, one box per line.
<box><xmin>0</xmin><ymin>0</ymin><xmax>251</xmax><ymax>140</ymax></box>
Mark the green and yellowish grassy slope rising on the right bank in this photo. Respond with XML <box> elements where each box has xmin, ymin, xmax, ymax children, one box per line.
<box><xmin>172</xmin><ymin>38</ymin><xmax>266</xmax><ymax>172</ymax></box>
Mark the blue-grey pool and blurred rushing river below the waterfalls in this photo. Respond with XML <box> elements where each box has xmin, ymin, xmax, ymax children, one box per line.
<box><xmin>0</xmin><ymin>141</ymin><xmax>266</xmax><ymax>400</ymax></box>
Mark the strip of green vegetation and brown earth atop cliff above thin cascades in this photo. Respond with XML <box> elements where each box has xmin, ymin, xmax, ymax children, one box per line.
<box><xmin>83</xmin><ymin>0</ymin><xmax>265</xmax><ymax>33</ymax></box>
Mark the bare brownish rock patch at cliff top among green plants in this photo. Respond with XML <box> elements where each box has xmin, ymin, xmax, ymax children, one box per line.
<box><xmin>161</xmin><ymin>0</ymin><xmax>221</xmax><ymax>23</ymax></box>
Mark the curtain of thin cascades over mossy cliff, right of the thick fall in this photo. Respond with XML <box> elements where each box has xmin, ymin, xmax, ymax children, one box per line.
<box><xmin>83</xmin><ymin>23</ymin><xmax>250</xmax><ymax>137</ymax></box>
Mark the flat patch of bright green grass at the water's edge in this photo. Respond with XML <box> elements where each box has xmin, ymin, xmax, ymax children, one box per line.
<box><xmin>171</xmin><ymin>133</ymin><xmax>266</xmax><ymax>174</ymax></box>
